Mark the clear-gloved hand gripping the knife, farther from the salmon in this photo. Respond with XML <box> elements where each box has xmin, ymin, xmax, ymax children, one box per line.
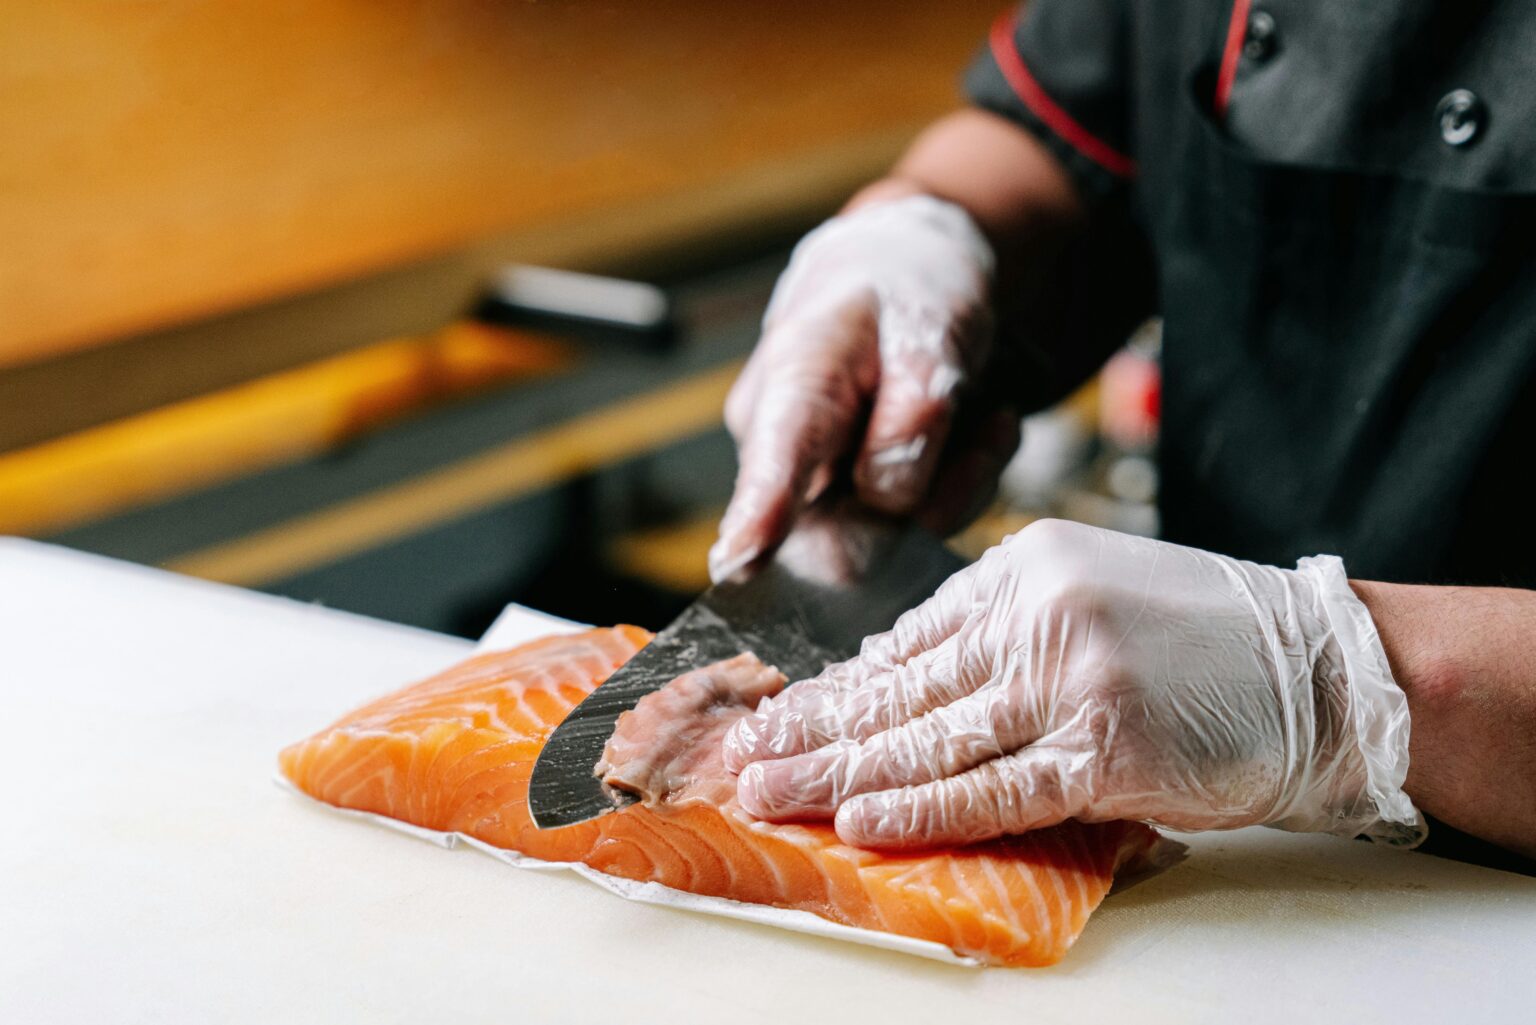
<box><xmin>710</xmin><ymin>195</ymin><xmax>1018</xmax><ymax>581</ymax></box>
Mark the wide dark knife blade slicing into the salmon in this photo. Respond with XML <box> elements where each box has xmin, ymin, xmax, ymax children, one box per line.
<box><xmin>528</xmin><ymin>503</ymin><xmax>965</xmax><ymax>830</ymax></box>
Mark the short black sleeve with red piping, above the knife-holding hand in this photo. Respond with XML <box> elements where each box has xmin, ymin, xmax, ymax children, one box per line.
<box><xmin>965</xmin><ymin>0</ymin><xmax>1137</xmax><ymax>200</ymax></box>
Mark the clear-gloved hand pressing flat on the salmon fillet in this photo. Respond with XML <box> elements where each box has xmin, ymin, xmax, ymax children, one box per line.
<box><xmin>725</xmin><ymin>521</ymin><xmax>1424</xmax><ymax>847</ymax></box>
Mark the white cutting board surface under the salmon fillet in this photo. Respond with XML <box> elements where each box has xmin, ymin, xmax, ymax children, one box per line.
<box><xmin>0</xmin><ymin>539</ymin><xmax>1536</xmax><ymax>1025</ymax></box>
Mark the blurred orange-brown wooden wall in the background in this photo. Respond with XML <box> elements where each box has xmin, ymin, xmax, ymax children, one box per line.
<box><xmin>0</xmin><ymin>0</ymin><xmax>1000</xmax><ymax>373</ymax></box>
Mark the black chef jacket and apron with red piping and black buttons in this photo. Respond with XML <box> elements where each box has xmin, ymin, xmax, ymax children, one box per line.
<box><xmin>968</xmin><ymin>0</ymin><xmax>1536</xmax><ymax>585</ymax></box>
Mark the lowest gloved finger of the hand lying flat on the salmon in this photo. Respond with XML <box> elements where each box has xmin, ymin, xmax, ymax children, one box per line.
<box><xmin>837</xmin><ymin>745</ymin><xmax>1084</xmax><ymax>848</ymax></box>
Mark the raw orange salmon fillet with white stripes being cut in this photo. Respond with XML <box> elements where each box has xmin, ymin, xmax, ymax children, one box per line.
<box><xmin>280</xmin><ymin>627</ymin><xmax>1160</xmax><ymax>965</ymax></box>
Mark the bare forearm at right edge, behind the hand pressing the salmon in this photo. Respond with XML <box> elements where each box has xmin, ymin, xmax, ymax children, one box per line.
<box><xmin>1353</xmin><ymin>581</ymin><xmax>1536</xmax><ymax>857</ymax></box>
